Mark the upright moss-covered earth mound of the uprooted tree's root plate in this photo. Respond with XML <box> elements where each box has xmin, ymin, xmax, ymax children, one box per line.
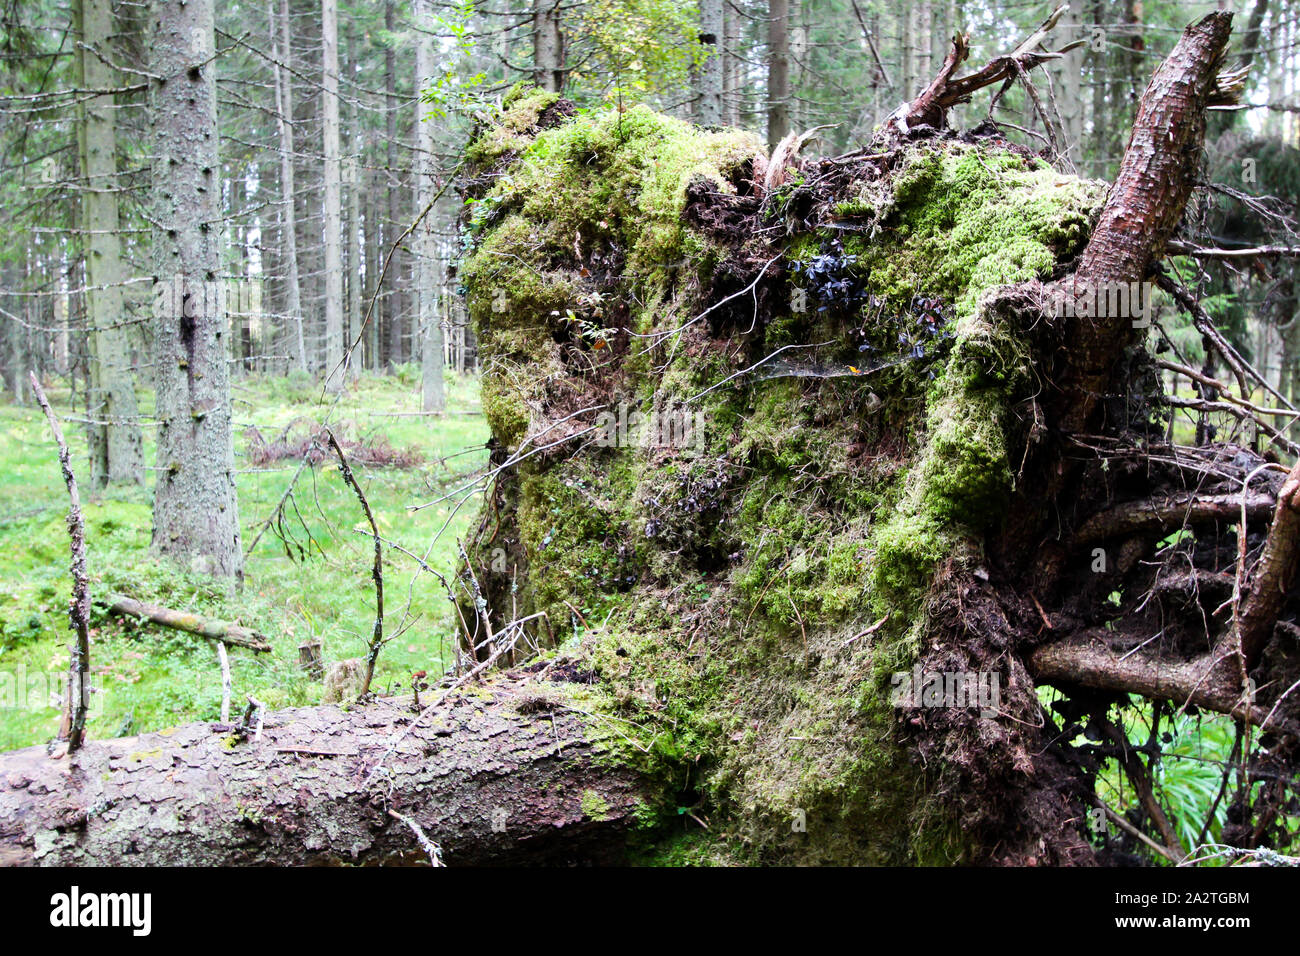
<box><xmin>460</xmin><ymin>91</ymin><xmax>1102</xmax><ymax>864</ymax></box>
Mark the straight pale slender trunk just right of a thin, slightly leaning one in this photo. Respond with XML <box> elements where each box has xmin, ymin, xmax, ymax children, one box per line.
<box><xmin>321</xmin><ymin>0</ymin><xmax>347</xmax><ymax>392</ymax></box>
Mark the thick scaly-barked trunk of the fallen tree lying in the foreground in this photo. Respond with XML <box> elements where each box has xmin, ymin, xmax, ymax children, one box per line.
<box><xmin>0</xmin><ymin>676</ymin><xmax>646</xmax><ymax>866</ymax></box>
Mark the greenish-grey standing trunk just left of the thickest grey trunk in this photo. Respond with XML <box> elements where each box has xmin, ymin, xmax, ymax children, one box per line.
<box><xmin>78</xmin><ymin>0</ymin><xmax>144</xmax><ymax>485</ymax></box>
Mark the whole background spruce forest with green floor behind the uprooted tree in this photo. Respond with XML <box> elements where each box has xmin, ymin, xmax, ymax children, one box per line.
<box><xmin>0</xmin><ymin>0</ymin><xmax>1300</xmax><ymax>868</ymax></box>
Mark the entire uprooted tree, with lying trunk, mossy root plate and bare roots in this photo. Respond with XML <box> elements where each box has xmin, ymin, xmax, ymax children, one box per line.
<box><xmin>0</xmin><ymin>13</ymin><xmax>1300</xmax><ymax>864</ymax></box>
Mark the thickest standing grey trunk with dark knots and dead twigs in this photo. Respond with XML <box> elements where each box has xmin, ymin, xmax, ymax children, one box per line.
<box><xmin>148</xmin><ymin>0</ymin><xmax>243</xmax><ymax>579</ymax></box>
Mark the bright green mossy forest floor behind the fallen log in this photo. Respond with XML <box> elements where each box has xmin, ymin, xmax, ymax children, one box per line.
<box><xmin>0</xmin><ymin>372</ymin><xmax>488</xmax><ymax>750</ymax></box>
